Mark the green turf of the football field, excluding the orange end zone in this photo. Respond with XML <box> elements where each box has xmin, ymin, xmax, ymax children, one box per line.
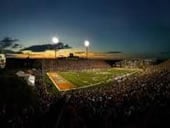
<box><xmin>58</xmin><ymin>68</ymin><xmax>134</xmax><ymax>87</ymax></box>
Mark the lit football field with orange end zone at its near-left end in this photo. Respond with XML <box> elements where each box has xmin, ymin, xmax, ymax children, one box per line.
<box><xmin>48</xmin><ymin>68</ymin><xmax>137</xmax><ymax>91</ymax></box>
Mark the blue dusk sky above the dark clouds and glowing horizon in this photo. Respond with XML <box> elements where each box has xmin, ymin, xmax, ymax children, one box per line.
<box><xmin>0</xmin><ymin>0</ymin><xmax>170</xmax><ymax>53</ymax></box>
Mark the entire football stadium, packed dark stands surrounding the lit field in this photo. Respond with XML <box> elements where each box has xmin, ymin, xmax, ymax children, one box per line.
<box><xmin>1</xmin><ymin>48</ymin><xmax>170</xmax><ymax>128</ymax></box>
